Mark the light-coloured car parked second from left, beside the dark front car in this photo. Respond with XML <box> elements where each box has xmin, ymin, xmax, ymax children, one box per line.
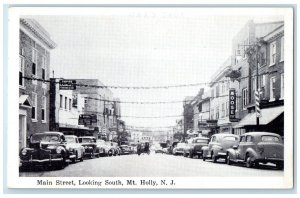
<box><xmin>65</xmin><ymin>135</ymin><xmax>84</xmax><ymax>163</ymax></box>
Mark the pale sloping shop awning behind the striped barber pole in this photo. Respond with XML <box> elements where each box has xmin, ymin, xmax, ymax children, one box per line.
<box><xmin>233</xmin><ymin>106</ymin><xmax>284</xmax><ymax>128</ymax></box>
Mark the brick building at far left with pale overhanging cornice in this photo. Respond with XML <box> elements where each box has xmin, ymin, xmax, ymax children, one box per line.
<box><xmin>19</xmin><ymin>18</ymin><xmax>56</xmax><ymax>148</ymax></box>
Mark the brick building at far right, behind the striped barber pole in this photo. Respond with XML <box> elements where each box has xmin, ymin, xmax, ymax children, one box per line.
<box><xmin>233</xmin><ymin>24</ymin><xmax>284</xmax><ymax>136</ymax></box>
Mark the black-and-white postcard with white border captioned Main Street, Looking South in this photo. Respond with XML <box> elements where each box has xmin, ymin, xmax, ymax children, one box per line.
<box><xmin>6</xmin><ymin>6</ymin><xmax>294</xmax><ymax>189</ymax></box>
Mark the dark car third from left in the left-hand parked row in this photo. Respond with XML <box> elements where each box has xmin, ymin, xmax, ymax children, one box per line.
<box><xmin>78</xmin><ymin>136</ymin><xmax>100</xmax><ymax>158</ymax></box>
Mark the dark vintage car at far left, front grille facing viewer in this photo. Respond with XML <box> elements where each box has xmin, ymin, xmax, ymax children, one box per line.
<box><xmin>20</xmin><ymin>131</ymin><xmax>69</xmax><ymax>169</ymax></box>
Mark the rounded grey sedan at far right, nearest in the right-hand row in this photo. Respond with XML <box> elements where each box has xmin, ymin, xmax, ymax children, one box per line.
<box><xmin>226</xmin><ymin>132</ymin><xmax>284</xmax><ymax>169</ymax></box>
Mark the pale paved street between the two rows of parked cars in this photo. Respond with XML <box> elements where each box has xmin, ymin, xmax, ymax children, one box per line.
<box><xmin>20</xmin><ymin>153</ymin><xmax>283</xmax><ymax>177</ymax></box>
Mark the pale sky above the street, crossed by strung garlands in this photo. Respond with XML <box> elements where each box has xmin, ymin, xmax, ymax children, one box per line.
<box><xmin>30</xmin><ymin>9</ymin><xmax>282</xmax><ymax>127</ymax></box>
